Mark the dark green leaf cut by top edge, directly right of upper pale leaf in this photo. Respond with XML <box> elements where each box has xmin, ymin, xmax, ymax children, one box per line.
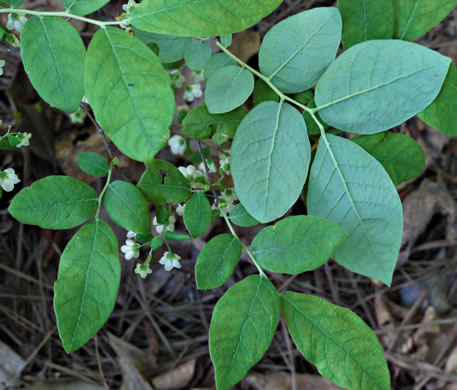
<box><xmin>338</xmin><ymin>0</ymin><xmax>394</xmax><ymax>50</ymax></box>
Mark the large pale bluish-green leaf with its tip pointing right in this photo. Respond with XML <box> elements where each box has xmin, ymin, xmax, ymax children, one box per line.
<box><xmin>315</xmin><ymin>40</ymin><xmax>451</xmax><ymax>134</ymax></box>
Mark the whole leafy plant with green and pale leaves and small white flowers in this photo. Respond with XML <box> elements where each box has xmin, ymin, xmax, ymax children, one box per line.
<box><xmin>0</xmin><ymin>0</ymin><xmax>457</xmax><ymax>390</ymax></box>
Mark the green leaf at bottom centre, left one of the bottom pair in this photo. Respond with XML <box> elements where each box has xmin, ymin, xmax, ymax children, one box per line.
<box><xmin>209</xmin><ymin>275</ymin><xmax>279</xmax><ymax>390</ymax></box>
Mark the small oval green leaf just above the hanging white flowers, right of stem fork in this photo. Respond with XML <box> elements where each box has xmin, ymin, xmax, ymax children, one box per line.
<box><xmin>103</xmin><ymin>180</ymin><xmax>152</xmax><ymax>234</ymax></box>
